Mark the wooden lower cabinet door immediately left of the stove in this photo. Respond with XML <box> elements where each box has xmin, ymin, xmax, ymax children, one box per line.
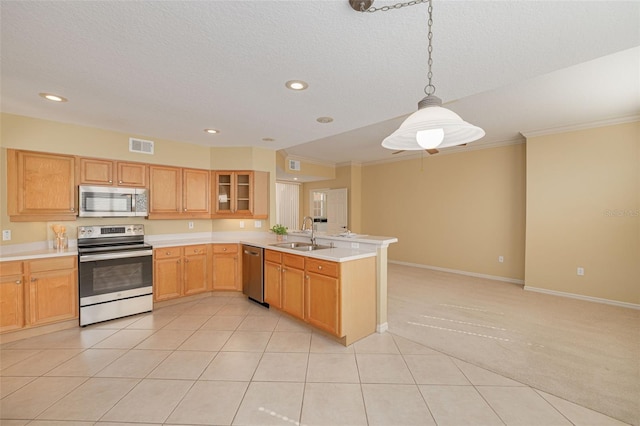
<box><xmin>26</xmin><ymin>257</ymin><xmax>78</xmax><ymax>325</ymax></box>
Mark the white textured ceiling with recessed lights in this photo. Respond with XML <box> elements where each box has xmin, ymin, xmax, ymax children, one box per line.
<box><xmin>0</xmin><ymin>0</ymin><xmax>640</xmax><ymax>172</ymax></box>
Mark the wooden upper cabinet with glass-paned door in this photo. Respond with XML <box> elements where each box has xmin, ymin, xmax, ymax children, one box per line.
<box><xmin>211</xmin><ymin>171</ymin><xmax>269</xmax><ymax>219</ymax></box>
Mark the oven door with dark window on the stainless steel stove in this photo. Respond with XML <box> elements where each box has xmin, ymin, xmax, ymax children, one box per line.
<box><xmin>78</xmin><ymin>249</ymin><xmax>153</xmax><ymax>306</ymax></box>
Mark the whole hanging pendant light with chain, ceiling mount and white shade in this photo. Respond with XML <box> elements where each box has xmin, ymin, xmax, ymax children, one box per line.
<box><xmin>350</xmin><ymin>0</ymin><xmax>484</xmax><ymax>151</ymax></box>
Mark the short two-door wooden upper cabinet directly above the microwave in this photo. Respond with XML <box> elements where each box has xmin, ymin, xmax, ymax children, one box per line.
<box><xmin>79</xmin><ymin>158</ymin><xmax>149</xmax><ymax>188</ymax></box>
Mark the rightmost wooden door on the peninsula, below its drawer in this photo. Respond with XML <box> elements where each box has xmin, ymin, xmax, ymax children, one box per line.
<box><xmin>305</xmin><ymin>272</ymin><xmax>342</xmax><ymax>337</ymax></box>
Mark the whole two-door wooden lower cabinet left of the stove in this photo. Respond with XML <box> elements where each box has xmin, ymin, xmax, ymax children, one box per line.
<box><xmin>0</xmin><ymin>256</ymin><xmax>78</xmax><ymax>332</ymax></box>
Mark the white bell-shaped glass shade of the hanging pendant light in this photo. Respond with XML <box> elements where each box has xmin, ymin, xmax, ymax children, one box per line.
<box><xmin>382</xmin><ymin>95</ymin><xmax>485</xmax><ymax>151</ymax></box>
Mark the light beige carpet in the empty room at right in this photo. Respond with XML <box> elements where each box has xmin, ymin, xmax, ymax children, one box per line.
<box><xmin>388</xmin><ymin>264</ymin><xmax>640</xmax><ymax>425</ymax></box>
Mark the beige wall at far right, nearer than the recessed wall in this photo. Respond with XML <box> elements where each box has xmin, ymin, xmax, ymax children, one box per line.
<box><xmin>525</xmin><ymin>122</ymin><xmax>640</xmax><ymax>304</ymax></box>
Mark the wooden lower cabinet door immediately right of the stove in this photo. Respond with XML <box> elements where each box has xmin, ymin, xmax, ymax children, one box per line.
<box><xmin>153</xmin><ymin>247</ymin><xmax>183</xmax><ymax>302</ymax></box>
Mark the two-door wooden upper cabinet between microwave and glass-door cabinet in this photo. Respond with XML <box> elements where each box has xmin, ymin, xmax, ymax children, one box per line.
<box><xmin>149</xmin><ymin>166</ymin><xmax>210</xmax><ymax>219</ymax></box>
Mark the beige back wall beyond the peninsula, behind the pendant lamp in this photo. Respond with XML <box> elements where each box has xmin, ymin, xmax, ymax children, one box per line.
<box><xmin>362</xmin><ymin>144</ymin><xmax>525</xmax><ymax>280</ymax></box>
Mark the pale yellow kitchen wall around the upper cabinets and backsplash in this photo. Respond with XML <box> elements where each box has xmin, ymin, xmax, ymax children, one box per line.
<box><xmin>0</xmin><ymin>113</ymin><xmax>275</xmax><ymax>245</ymax></box>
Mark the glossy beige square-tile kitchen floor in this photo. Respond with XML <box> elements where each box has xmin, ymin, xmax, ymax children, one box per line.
<box><xmin>0</xmin><ymin>294</ymin><xmax>623</xmax><ymax>426</ymax></box>
